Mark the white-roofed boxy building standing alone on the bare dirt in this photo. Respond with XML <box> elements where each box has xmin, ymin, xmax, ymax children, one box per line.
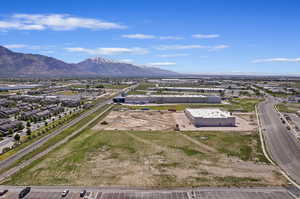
<box><xmin>185</xmin><ymin>109</ymin><xmax>235</xmax><ymax>127</ymax></box>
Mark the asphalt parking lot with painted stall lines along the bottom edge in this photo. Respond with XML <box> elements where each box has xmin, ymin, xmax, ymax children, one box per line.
<box><xmin>0</xmin><ymin>189</ymin><xmax>294</xmax><ymax>199</ymax></box>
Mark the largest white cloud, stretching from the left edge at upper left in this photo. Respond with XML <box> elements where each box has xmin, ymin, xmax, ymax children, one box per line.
<box><xmin>0</xmin><ymin>14</ymin><xmax>126</xmax><ymax>30</ymax></box>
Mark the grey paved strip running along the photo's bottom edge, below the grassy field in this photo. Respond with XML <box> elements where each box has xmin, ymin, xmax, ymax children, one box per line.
<box><xmin>0</xmin><ymin>187</ymin><xmax>294</xmax><ymax>199</ymax></box>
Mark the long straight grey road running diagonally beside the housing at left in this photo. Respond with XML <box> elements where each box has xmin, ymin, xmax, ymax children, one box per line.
<box><xmin>0</xmin><ymin>85</ymin><xmax>137</xmax><ymax>169</ymax></box>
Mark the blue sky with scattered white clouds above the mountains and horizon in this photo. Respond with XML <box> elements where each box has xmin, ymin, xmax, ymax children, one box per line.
<box><xmin>0</xmin><ymin>0</ymin><xmax>300</xmax><ymax>75</ymax></box>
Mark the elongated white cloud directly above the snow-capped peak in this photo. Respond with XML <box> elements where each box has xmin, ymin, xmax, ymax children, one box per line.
<box><xmin>64</xmin><ymin>47</ymin><xmax>148</xmax><ymax>55</ymax></box>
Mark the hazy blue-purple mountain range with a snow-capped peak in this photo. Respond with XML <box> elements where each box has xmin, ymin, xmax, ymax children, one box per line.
<box><xmin>0</xmin><ymin>46</ymin><xmax>179</xmax><ymax>77</ymax></box>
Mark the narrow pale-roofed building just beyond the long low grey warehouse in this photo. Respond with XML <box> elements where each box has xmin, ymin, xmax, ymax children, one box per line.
<box><xmin>149</xmin><ymin>87</ymin><xmax>225</xmax><ymax>93</ymax></box>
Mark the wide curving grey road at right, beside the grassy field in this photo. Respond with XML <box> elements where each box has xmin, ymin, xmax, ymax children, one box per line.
<box><xmin>258</xmin><ymin>96</ymin><xmax>300</xmax><ymax>184</ymax></box>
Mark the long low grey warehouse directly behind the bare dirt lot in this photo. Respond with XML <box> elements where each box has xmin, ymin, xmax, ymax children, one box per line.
<box><xmin>125</xmin><ymin>95</ymin><xmax>221</xmax><ymax>104</ymax></box>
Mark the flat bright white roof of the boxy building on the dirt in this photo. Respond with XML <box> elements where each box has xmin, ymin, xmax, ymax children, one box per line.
<box><xmin>185</xmin><ymin>108</ymin><xmax>232</xmax><ymax>118</ymax></box>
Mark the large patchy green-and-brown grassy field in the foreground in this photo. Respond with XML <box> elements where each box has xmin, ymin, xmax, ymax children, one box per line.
<box><xmin>6</xmin><ymin>130</ymin><xmax>286</xmax><ymax>187</ymax></box>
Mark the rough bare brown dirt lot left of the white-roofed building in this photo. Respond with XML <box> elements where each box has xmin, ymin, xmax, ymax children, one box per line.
<box><xmin>93</xmin><ymin>110</ymin><xmax>176</xmax><ymax>131</ymax></box>
